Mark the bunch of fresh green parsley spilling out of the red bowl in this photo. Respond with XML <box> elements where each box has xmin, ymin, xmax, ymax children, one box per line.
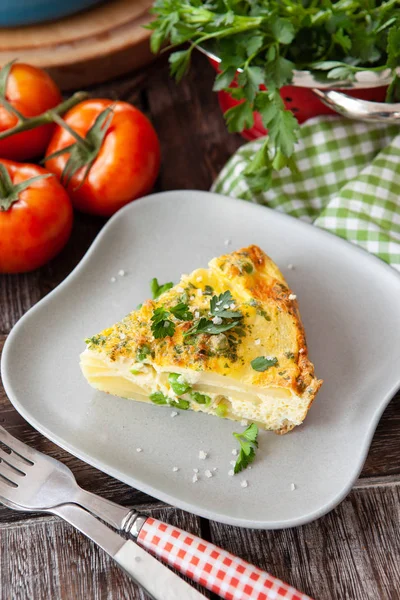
<box><xmin>149</xmin><ymin>0</ymin><xmax>400</xmax><ymax>192</ymax></box>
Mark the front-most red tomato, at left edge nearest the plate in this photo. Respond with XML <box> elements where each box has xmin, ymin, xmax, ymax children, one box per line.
<box><xmin>0</xmin><ymin>160</ymin><xmax>73</xmax><ymax>273</ymax></box>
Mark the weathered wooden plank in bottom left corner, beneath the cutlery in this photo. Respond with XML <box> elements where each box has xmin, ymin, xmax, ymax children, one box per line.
<box><xmin>0</xmin><ymin>505</ymin><xmax>208</xmax><ymax>600</ymax></box>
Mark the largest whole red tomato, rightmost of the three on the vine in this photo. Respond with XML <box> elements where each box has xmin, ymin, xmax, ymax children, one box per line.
<box><xmin>46</xmin><ymin>100</ymin><xmax>160</xmax><ymax>216</ymax></box>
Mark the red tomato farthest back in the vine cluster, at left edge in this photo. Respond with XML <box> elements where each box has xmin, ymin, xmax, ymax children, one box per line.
<box><xmin>0</xmin><ymin>63</ymin><xmax>62</xmax><ymax>160</ymax></box>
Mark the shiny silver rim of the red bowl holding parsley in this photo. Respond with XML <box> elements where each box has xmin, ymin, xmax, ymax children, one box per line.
<box><xmin>197</xmin><ymin>46</ymin><xmax>400</xmax><ymax>90</ymax></box>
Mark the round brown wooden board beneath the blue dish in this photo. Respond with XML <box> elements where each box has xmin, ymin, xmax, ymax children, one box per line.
<box><xmin>0</xmin><ymin>0</ymin><xmax>153</xmax><ymax>90</ymax></box>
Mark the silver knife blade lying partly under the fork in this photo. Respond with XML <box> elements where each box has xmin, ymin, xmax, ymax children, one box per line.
<box><xmin>49</xmin><ymin>504</ymin><xmax>205</xmax><ymax>600</ymax></box>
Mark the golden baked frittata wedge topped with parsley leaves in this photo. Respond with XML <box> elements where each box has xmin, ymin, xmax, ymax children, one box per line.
<box><xmin>81</xmin><ymin>246</ymin><xmax>322</xmax><ymax>433</ymax></box>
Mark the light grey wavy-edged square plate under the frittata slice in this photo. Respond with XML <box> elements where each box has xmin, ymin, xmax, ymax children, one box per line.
<box><xmin>2</xmin><ymin>191</ymin><xmax>400</xmax><ymax>529</ymax></box>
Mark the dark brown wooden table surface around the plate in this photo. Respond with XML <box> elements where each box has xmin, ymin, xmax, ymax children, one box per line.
<box><xmin>0</xmin><ymin>55</ymin><xmax>400</xmax><ymax>600</ymax></box>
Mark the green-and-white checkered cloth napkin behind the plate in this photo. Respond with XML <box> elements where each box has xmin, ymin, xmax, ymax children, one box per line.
<box><xmin>213</xmin><ymin>117</ymin><xmax>400</xmax><ymax>271</ymax></box>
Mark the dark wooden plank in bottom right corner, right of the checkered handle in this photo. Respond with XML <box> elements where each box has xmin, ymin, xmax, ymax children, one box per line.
<box><xmin>210</xmin><ymin>485</ymin><xmax>400</xmax><ymax>600</ymax></box>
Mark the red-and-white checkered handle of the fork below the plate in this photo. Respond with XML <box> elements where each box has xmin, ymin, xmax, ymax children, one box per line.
<box><xmin>137</xmin><ymin>517</ymin><xmax>311</xmax><ymax>600</ymax></box>
